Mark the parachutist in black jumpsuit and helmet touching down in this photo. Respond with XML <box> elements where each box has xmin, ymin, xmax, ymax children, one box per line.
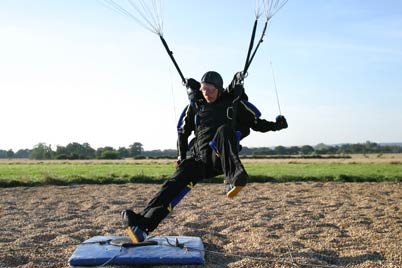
<box><xmin>122</xmin><ymin>71</ymin><xmax>287</xmax><ymax>243</ymax></box>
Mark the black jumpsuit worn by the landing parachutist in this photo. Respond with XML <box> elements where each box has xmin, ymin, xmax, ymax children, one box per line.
<box><xmin>138</xmin><ymin>94</ymin><xmax>276</xmax><ymax>233</ymax></box>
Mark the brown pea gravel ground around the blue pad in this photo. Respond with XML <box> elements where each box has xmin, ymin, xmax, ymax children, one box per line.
<box><xmin>0</xmin><ymin>182</ymin><xmax>402</xmax><ymax>268</ymax></box>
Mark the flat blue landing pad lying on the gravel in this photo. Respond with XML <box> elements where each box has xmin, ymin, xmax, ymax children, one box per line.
<box><xmin>68</xmin><ymin>236</ymin><xmax>205</xmax><ymax>266</ymax></box>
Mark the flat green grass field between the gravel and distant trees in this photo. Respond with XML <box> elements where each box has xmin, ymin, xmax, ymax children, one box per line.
<box><xmin>0</xmin><ymin>154</ymin><xmax>402</xmax><ymax>187</ymax></box>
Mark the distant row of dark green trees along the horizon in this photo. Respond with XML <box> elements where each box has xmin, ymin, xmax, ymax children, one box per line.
<box><xmin>0</xmin><ymin>141</ymin><xmax>402</xmax><ymax>160</ymax></box>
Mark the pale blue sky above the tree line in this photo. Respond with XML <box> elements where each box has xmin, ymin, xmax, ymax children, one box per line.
<box><xmin>0</xmin><ymin>0</ymin><xmax>402</xmax><ymax>150</ymax></box>
